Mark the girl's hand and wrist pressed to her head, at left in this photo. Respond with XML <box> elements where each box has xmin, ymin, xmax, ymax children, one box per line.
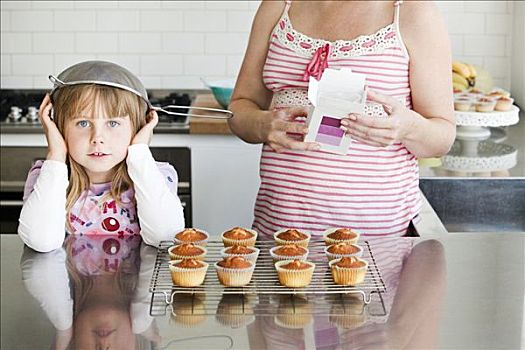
<box><xmin>38</xmin><ymin>94</ymin><xmax>67</xmax><ymax>163</ymax></box>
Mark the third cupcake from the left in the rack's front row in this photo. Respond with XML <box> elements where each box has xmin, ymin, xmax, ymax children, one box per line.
<box><xmin>275</xmin><ymin>260</ymin><xmax>315</xmax><ymax>288</ymax></box>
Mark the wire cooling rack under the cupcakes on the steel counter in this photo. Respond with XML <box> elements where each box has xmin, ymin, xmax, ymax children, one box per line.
<box><xmin>150</xmin><ymin>240</ymin><xmax>386</xmax><ymax>316</ymax></box>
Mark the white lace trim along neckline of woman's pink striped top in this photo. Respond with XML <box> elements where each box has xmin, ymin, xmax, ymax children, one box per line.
<box><xmin>272</xmin><ymin>10</ymin><xmax>401</xmax><ymax>58</ymax></box>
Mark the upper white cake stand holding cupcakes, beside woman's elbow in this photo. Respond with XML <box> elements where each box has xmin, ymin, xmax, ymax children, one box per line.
<box><xmin>454</xmin><ymin>106</ymin><xmax>520</xmax><ymax>140</ymax></box>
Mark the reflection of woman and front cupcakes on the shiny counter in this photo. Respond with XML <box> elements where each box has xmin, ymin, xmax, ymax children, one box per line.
<box><xmin>161</xmin><ymin>238</ymin><xmax>446</xmax><ymax>349</ymax></box>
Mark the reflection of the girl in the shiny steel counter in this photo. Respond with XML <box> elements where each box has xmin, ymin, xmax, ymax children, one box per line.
<box><xmin>20</xmin><ymin>235</ymin><xmax>160</xmax><ymax>349</ymax></box>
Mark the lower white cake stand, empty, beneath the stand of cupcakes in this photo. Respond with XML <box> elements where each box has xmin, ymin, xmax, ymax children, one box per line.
<box><xmin>441</xmin><ymin>140</ymin><xmax>518</xmax><ymax>173</ymax></box>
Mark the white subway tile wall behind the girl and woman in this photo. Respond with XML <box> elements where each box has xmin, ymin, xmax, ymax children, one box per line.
<box><xmin>0</xmin><ymin>0</ymin><xmax>513</xmax><ymax>89</ymax></box>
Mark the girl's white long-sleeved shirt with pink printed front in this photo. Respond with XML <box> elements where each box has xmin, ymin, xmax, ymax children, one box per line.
<box><xmin>18</xmin><ymin>144</ymin><xmax>184</xmax><ymax>252</ymax></box>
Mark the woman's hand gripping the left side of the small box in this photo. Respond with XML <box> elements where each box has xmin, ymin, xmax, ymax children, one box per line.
<box><xmin>263</xmin><ymin>107</ymin><xmax>320</xmax><ymax>153</ymax></box>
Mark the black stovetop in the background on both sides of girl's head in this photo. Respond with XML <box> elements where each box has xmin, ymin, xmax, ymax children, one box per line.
<box><xmin>0</xmin><ymin>89</ymin><xmax>194</xmax><ymax>134</ymax></box>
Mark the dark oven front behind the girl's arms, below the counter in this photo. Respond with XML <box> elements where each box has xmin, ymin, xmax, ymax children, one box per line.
<box><xmin>0</xmin><ymin>146</ymin><xmax>192</xmax><ymax>233</ymax></box>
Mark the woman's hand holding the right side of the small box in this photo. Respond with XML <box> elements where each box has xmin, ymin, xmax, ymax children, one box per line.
<box><xmin>341</xmin><ymin>91</ymin><xmax>414</xmax><ymax>147</ymax></box>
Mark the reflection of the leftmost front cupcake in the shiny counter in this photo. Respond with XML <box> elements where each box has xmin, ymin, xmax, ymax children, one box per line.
<box><xmin>171</xmin><ymin>294</ymin><xmax>206</xmax><ymax>327</ymax></box>
